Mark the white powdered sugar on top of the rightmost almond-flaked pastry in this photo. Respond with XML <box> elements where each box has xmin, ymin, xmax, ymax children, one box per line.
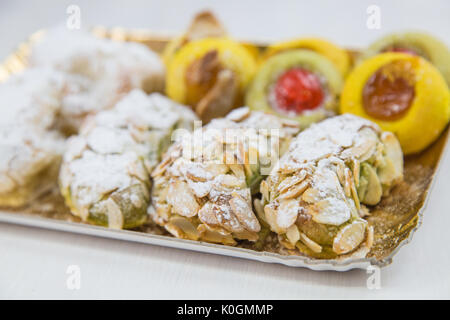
<box><xmin>268</xmin><ymin>114</ymin><xmax>380</xmax><ymax>232</ymax></box>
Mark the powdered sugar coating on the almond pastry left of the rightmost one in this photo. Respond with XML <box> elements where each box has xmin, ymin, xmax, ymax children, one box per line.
<box><xmin>153</xmin><ymin>107</ymin><xmax>298</xmax><ymax>241</ymax></box>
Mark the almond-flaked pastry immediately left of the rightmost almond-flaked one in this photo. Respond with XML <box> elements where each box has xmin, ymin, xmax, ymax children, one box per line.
<box><xmin>149</xmin><ymin>107</ymin><xmax>298</xmax><ymax>245</ymax></box>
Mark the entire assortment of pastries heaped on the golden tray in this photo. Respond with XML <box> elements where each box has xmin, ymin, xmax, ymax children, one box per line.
<box><xmin>0</xmin><ymin>13</ymin><xmax>450</xmax><ymax>259</ymax></box>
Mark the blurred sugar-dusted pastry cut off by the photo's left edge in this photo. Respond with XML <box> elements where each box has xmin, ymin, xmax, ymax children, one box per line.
<box><xmin>0</xmin><ymin>68</ymin><xmax>64</xmax><ymax>207</ymax></box>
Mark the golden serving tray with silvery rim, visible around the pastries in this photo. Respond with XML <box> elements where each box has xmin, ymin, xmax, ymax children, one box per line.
<box><xmin>0</xmin><ymin>27</ymin><xmax>450</xmax><ymax>271</ymax></box>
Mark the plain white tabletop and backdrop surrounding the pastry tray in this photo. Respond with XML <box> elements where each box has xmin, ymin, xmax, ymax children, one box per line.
<box><xmin>0</xmin><ymin>0</ymin><xmax>450</xmax><ymax>299</ymax></box>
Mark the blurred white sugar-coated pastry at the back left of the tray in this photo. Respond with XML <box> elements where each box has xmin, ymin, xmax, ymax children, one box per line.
<box><xmin>29</xmin><ymin>28</ymin><xmax>165</xmax><ymax>133</ymax></box>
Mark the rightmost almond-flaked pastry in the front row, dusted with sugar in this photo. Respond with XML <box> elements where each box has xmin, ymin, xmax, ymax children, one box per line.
<box><xmin>261</xmin><ymin>114</ymin><xmax>403</xmax><ymax>258</ymax></box>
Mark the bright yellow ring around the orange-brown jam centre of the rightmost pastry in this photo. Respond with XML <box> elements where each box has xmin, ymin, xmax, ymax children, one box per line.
<box><xmin>340</xmin><ymin>53</ymin><xmax>450</xmax><ymax>154</ymax></box>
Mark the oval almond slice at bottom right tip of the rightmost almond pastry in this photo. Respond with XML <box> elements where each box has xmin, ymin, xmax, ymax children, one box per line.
<box><xmin>333</xmin><ymin>221</ymin><xmax>367</xmax><ymax>254</ymax></box>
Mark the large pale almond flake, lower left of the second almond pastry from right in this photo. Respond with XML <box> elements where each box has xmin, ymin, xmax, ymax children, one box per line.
<box><xmin>167</xmin><ymin>180</ymin><xmax>200</xmax><ymax>217</ymax></box>
